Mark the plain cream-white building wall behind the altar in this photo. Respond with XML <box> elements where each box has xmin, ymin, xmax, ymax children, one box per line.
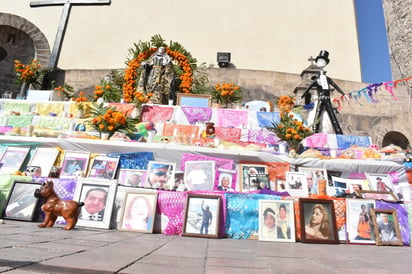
<box><xmin>0</xmin><ymin>0</ymin><xmax>361</xmax><ymax>82</ymax></box>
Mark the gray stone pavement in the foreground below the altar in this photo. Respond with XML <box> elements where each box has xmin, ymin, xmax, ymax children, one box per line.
<box><xmin>0</xmin><ymin>220</ymin><xmax>412</xmax><ymax>274</ymax></box>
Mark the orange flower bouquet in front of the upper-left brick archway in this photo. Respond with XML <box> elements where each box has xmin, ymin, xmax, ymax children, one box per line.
<box><xmin>14</xmin><ymin>60</ymin><xmax>42</xmax><ymax>87</ymax></box>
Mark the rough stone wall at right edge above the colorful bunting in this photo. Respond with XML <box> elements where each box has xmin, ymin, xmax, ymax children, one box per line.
<box><xmin>383</xmin><ymin>0</ymin><xmax>412</xmax><ymax>80</ymax></box>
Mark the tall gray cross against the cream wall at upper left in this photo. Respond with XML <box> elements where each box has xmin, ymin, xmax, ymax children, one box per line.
<box><xmin>30</xmin><ymin>0</ymin><xmax>111</xmax><ymax>69</ymax></box>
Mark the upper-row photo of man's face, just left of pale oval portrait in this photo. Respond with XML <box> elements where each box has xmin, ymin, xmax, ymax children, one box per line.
<box><xmin>144</xmin><ymin>161</ymin><xmax>176</xmax><ymax>189</ymax></box>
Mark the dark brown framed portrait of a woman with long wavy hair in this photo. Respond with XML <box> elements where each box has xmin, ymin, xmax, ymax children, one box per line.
<box><xmin>299</xmin><ymin>198</ymin><xmax>339</xmax><ymax>244</ymax></box>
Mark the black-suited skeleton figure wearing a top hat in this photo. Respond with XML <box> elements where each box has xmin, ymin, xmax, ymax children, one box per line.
<box><xmin>301</xmin><ymin>50</ymin><xmax>345</xmax><ymax>134</ymax></box>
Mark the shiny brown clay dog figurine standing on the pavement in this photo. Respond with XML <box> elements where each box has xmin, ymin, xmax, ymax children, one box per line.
<box><xmin>34</xmin><ymin>181</ymin><xmax>84</xmax><ymax>230</ymax></box>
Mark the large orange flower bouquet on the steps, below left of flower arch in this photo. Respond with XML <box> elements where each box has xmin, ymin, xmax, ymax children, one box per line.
<box><xmin>89</xmin><ymin>103</ymin><xmax>139</xmax><ymax>136</ymax></box>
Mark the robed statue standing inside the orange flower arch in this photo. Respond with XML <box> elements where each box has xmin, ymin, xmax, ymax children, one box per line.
<box><xmin>137</xmin><ymin>47</ymin><xmax>175</xmax><ymax>105</ymax></box>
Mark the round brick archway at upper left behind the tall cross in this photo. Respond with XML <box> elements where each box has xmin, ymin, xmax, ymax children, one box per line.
<box><xmin>0</xmin><ymin>13</ymin><xmax>51</xmax><ymax>92</ymax></box>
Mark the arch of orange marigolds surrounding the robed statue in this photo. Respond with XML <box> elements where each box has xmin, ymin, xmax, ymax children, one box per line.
<box><xmin>123</xmin><ymin>35</ymin><xmax>196</xmax><ymax>103</ymax></box>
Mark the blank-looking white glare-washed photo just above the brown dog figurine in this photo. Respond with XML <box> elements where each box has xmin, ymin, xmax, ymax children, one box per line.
<box><xmin>28</xmin><ymin>147</ymin><xmax>60</xmax><ymax>177</ymax></box>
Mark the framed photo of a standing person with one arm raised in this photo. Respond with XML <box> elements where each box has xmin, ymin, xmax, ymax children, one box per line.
<box><xmin>182</xmin><ymin>193</ymin><xmax>221</xmax><ymax>238</ymax></box>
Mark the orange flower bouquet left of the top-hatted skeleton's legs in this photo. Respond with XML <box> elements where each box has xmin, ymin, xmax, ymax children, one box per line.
<box><xmin>268</xmin><ymin>96</ymin><xmax>313</xmax><ymax>152</ymax></box>
